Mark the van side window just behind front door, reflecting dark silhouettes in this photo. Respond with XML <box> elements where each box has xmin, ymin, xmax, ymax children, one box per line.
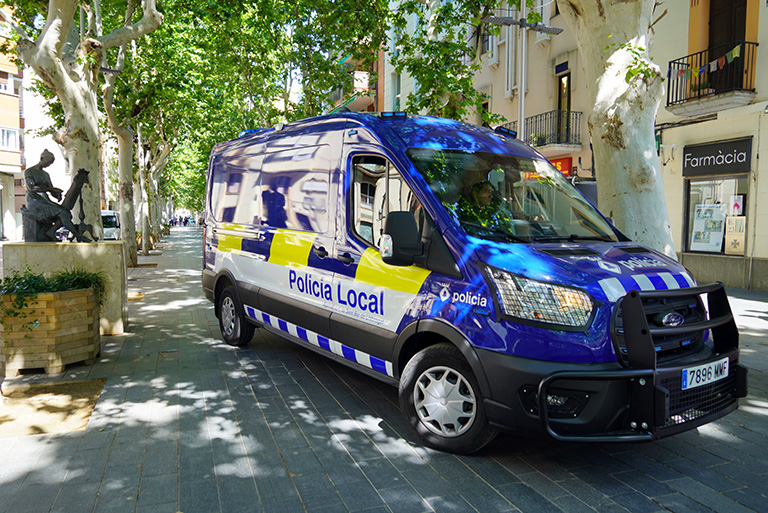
<box><xmin>256</xmin><ymin>146</ymin><xmax>331</xmax><ymax>233</ymax></box>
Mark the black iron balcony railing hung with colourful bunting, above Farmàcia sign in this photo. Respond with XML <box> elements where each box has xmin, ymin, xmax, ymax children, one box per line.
<box><xmin>667</xmin><ymin>41</ymin><xmax>757</xmax><ymax>106</ymax></box>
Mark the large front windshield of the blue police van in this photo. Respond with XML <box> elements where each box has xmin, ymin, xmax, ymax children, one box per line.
<box><xmin>407</xmin><ymin>148</ymin><xmax>618</xmax><ymax>242</ymax></box>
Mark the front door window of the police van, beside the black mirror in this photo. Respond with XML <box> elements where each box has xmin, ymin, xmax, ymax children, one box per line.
<box><xmin>352</xmin><ymin>155</ymin><xmax>426</xmax><ymax>248</ymax></box>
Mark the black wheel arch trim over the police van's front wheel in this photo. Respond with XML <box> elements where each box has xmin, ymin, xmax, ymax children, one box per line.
<box><xmin>393</xmin><ymin>319</ymin><xmax>491</xmax><ymax>399</ymax></box>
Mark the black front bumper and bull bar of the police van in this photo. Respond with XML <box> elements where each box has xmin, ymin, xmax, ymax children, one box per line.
<box><xmin>479</xmin><ymin>284</ymin><xmax>747</xmax><ymax>442</ymax></box>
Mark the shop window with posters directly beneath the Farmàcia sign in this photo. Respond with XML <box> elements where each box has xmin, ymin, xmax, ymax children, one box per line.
<box><xmin>686</xmin><ymin>176</ymin><xmax>749</xmax><ymax>255</ymax></box>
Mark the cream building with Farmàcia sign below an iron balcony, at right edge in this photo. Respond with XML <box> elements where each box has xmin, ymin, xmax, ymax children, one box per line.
<box><xmin>652</xmin><ymin>0</ymin><xmax>768</xmax><ymax>290</ymax></box>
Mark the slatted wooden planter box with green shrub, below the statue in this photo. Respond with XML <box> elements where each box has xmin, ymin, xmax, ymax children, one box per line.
<box><xmin>0</xmin><ymin>268</ymin><xmax>107</xmax><ymax>377</ymax></box>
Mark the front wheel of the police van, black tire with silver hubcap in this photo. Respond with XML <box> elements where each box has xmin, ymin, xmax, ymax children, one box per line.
<box><xmin>399</xmin><ymin>344</ymin><xmax>496</xmax><ymax>454</ymax></box>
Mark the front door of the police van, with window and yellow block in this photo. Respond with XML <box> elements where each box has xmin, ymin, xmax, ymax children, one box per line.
<box><xmin>331</xmin><ymin>152</ymin><xmax>430</xmax><ymax>370</ymax></box>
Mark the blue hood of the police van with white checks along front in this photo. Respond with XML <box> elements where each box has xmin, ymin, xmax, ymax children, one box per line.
<box><xmin>475</xmin><ymin>241</ymin><xmax>696</xmax><ymax>302</ymax></box>
